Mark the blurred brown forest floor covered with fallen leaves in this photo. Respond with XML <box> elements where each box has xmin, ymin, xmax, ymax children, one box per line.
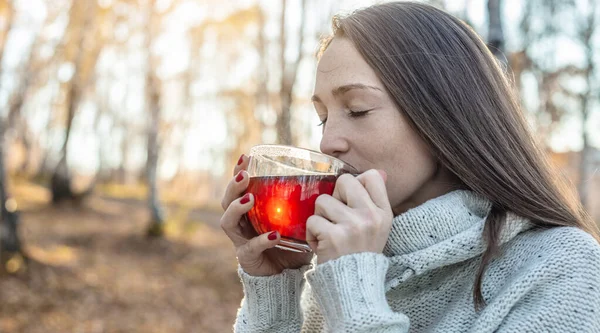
<box><xmin>0</xmin><ymin>182</ymin><xmax>242</xmax><ymax>333</ymax></box>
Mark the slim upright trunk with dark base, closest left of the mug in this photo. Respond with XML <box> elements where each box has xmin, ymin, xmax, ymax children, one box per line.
<box><xmin>146</xmin><ymin>1</ymin><xmax>164</xmax><ymax>237</ymax></box>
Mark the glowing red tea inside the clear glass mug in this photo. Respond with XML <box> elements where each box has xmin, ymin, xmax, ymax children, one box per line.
<box><xmin>247</xmin><ymin>175</ymin><xmax>337</xmax><ymax>242</ymax></box>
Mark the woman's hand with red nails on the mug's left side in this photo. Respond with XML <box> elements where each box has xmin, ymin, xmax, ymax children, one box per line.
<box><xmin>221</xmin><ymin>155</ymin><xmax>313</xmax><ymax>276</ymax></box>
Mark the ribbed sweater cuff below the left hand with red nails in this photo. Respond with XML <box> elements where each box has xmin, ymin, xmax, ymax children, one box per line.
<box><xmin>234</xmin><ymin>265</ymin><xmax>310</xmax><ymax>333</ymax></box>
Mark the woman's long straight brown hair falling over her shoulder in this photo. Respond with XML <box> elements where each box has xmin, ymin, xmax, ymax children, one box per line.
<box><xmin>320</xmin><ymin>2</ymin><xmax>599</xmax><ymax>310</ymax></box>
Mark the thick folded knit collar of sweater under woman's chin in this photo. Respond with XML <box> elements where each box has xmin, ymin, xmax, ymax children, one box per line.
<box><xmin>383</xmin><ymin>190</ymin><xmax>533</xmax><ymax>290</ymax></box>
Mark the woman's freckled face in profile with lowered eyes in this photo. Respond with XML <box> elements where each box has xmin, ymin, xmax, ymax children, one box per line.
<box><xmin>312</xmin><ymin>37</ymin><xmax>458</xmax><ymax>214</ymax></box>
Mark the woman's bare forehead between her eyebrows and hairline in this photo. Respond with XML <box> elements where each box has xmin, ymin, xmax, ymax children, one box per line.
<box><xmin>315</xmin><ymin>37</ymin><xmax>382</xmax><ymax>91</ymax></box>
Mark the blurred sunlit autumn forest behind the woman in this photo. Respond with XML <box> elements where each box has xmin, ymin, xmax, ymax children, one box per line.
<box><xmin>0</xmin><ymin>0</ymin><xmax>600</xmax><ymax>332</ymax></box>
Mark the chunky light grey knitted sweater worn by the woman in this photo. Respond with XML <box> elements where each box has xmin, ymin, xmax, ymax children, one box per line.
<box><xmin>234</xmin><ymin>190</ymin><xmax>600</xmax><ymax>333</ymax></box>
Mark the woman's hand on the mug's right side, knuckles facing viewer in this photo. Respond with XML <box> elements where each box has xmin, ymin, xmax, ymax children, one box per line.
<box><xmin>306</xmin><ymin>169</ymin><xmax>393</xmax><ymax>263</ymax></box>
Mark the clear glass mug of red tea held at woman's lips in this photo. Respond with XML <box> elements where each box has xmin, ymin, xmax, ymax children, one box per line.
<box><xmin>246</xmin><ymin>145</ymin><xmax>357</xmax><ymax>252</ymax></box>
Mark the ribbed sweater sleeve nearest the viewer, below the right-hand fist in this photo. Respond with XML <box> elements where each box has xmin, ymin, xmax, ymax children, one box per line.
<box><xmin>306</xmin><ymin>253</ymin><xmax>409</xmax><ymax>333</ymax></box>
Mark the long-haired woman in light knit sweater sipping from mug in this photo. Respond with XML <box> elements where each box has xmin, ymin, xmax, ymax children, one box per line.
<box><xmin>221</xmin><ymin>2</ymin><xmax>600</xmax><ymax>332</ymax></box>
